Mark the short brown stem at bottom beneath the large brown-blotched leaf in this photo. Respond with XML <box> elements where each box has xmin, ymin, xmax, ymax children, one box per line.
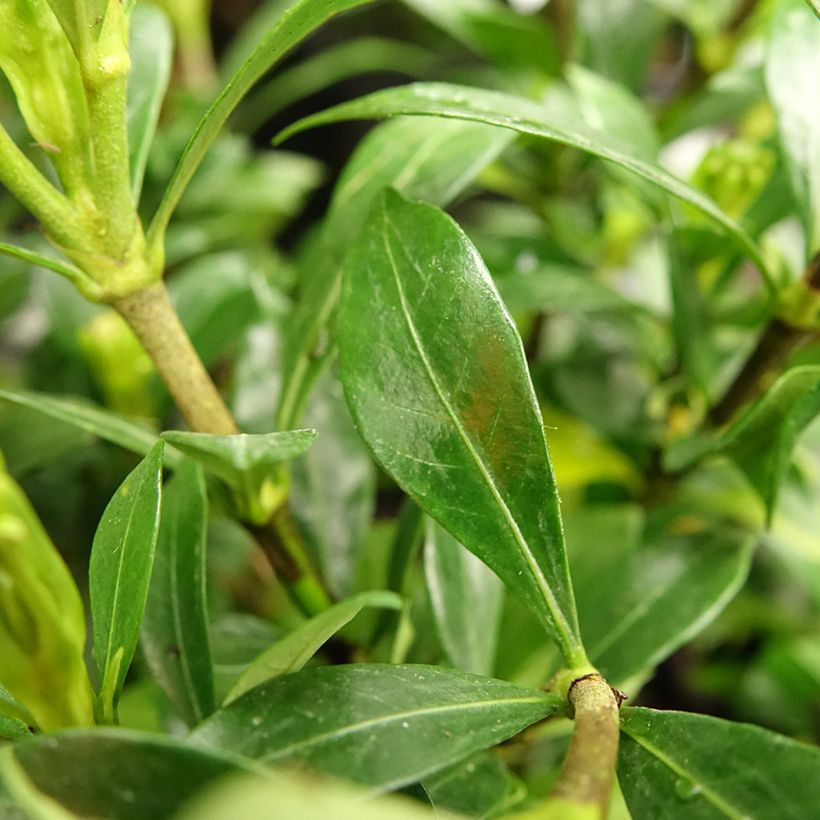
<box><xmin>534</xmin><ymin>673</ymin><xmax>619</xmax><ymax>820</ymax></box>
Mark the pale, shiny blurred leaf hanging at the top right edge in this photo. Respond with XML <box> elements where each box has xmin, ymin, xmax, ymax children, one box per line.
<box><xmin>766</xmin><ymin>0</ymin><xmax>820</xmax><ymax>258</ymax></box>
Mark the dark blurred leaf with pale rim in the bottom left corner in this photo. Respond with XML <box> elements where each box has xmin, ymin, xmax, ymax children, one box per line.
<box><xmin>0</xmin><ymin>728</ymin><xmax>267</xmax><ymax>820</ymax></box>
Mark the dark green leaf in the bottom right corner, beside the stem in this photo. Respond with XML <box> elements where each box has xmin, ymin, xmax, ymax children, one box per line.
<box><xmin>618</xmin><ymin>708</ymin><xmax>820</xmax><ymax>820</ymax></box>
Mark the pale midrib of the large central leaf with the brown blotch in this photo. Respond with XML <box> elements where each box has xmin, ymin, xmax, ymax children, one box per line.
<box><xmin>382</xmin><ymin>206</ymin><xmax>575</xmax><ymax>656</ymax></box>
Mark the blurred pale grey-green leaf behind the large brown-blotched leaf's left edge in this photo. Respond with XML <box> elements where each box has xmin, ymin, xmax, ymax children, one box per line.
<box><xmin>290</xmin><ymin>374</ymin><xmax>376</xmax><ymax>599</ymax></box>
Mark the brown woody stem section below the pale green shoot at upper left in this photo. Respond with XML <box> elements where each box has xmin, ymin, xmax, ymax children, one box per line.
<box><xmin>113</xmin><ymin>282</ymin><xmax>239</xmax><ymax>436</ymax></box>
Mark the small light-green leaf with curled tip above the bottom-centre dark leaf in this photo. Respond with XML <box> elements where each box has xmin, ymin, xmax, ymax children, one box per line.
<box><xmin>225</xmin><ymin>591</ymin><xmax>402</xmax><ymax>705</ymax></box>
